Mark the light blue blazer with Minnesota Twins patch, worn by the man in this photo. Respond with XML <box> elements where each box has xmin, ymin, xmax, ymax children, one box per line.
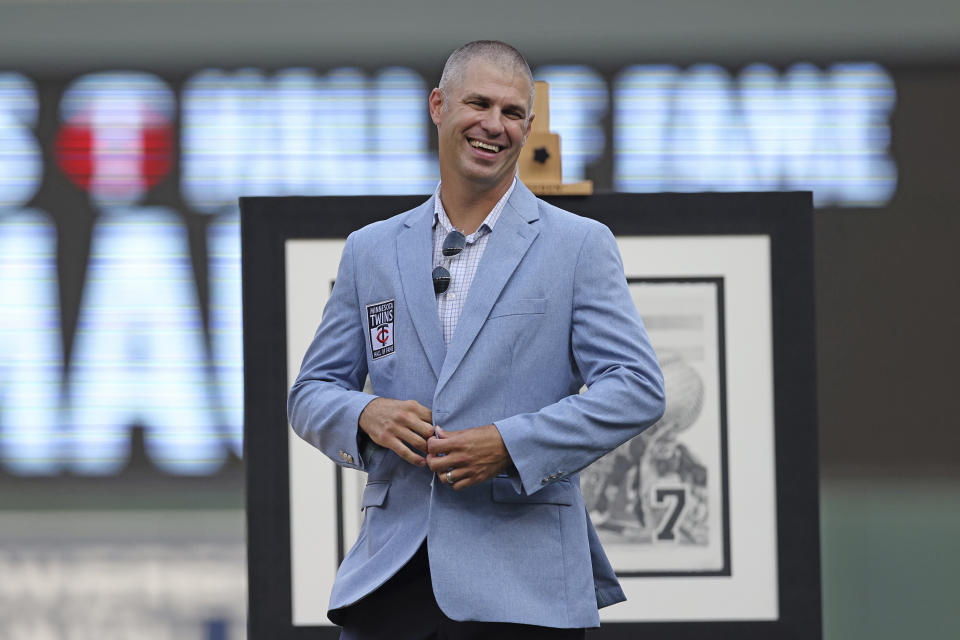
<box><xmin>288</xmin><ymin>183</ymin><xmax>664</xmax><ymax>627</ymax></box>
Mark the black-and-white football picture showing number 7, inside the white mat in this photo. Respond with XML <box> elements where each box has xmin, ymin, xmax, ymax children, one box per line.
<box><xmin>580</xmin><ymin>276</ymin><xmax>730</xmax><ymax>578</ymax></box>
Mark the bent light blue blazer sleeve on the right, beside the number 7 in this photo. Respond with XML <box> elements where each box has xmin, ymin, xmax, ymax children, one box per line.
<box><xmin>496</xmin><ymin>223</ymin><xmax>664</xmax><ymax>495</ymax></box>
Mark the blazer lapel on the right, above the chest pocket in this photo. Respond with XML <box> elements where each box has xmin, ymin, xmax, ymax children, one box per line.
<box><xmin>434</xmin><ymin>183</ymin><xmax>540</xmax><ymax>391</ymax></box>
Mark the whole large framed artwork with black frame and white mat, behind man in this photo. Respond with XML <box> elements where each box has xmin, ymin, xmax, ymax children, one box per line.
<box><xmin>241</xmin><ymin>193</ymin><xmax>821</xmax><ymax>639</ymax></box>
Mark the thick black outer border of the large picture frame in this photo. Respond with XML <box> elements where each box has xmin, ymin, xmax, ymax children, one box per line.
<box><xmin>240</xmin><ymin>192</ymin><xmax>822</xmax><ymax>640</ymax></box>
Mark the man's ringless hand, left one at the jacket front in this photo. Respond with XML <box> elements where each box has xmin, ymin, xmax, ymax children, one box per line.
<box><xmin>359</xmin><ymin>398</ymin><xmax>433</xmax><ymax>467</ymax></box>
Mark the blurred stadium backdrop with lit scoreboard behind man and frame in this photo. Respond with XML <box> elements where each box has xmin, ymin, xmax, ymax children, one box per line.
<box><xmin>0</xmin><ymin>0</ymin><xmax>960</xmax><ymax>640</ymax></box>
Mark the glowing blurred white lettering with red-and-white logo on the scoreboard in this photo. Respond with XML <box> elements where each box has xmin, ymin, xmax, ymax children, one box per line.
<box><xmin>0</xmin><ymin>63</ymin><xmax>897</xmax><ymax>475</ymax></box>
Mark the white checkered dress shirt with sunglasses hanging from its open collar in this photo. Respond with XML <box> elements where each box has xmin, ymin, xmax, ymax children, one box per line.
<box><xmin>433</xmin><ymin>178</ymin><xmax>517</xmax><ymax>346</ymax></box>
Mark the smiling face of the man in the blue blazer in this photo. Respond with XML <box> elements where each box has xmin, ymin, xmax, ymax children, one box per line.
<box><xmin>430</xmin><ymin>60</ymin><xmax>533</xmax><ymax>194</ymax></box>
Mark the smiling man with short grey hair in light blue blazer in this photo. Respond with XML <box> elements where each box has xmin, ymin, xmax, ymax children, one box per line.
<box><xmin>289</xmin><ymin>41</ymin><xmax>664</xmax><ymax>640</ymax></box>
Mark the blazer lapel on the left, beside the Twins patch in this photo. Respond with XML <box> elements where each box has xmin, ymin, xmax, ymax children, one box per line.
<box><xmin>397</xmin><ymin>198</ymin><xmax>446</xmax><ymax>377</ymax></box>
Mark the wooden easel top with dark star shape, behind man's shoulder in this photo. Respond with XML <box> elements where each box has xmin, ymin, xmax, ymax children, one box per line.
<box><xmin>519</xmin><ymin>82</ymin><xmax>593</xmax><ymax>196</ymax></box>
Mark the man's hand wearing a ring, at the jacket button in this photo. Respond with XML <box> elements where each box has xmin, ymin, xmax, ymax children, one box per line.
<box><xmin>427</xmin><ymin>424</ymin><xmax>510</xmax><ymax>491</ymax></box>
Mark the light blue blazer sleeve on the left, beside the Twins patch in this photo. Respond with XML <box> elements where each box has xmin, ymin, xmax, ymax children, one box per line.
<box><xmin>287</xmin><ymin>234</ymin><xmax>376</xmax><ymax>469</ymax></box>
